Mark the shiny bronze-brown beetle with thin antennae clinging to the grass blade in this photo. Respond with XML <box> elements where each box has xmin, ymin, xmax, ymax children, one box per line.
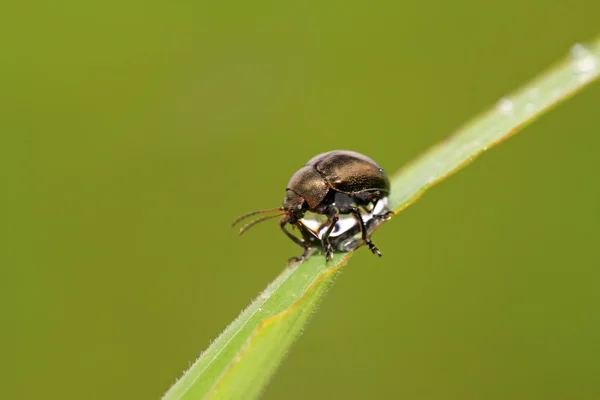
<box><xmin>232</xmin><ymin>150</ymin><xmax>394</xmax><ymax>262</ymax></box>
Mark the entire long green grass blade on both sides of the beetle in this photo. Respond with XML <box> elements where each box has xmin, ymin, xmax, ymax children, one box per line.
<box><xmin>164</xmin><ymin>39</ymin><xmax>600</xmax><ymax>400</ymax></box>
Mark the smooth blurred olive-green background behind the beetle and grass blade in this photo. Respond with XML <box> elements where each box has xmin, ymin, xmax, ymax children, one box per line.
<box><xmin>0</xmin><ymin>0</ymin><xmax>600</xmax><ymax>399</ymax></box>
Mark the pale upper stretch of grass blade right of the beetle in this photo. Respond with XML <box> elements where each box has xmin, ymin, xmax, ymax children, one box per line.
<box><xmin>390</xmin><ymin>42</ymin><xmax>600</xmax><ymax>210</ymax></box>
